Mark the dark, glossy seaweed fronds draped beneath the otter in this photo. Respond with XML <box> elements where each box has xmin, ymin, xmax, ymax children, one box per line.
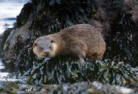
<box><xmin>26</xmin><ymin>57</ymin><xmax>138</xmax><ymax>85</ymax></box>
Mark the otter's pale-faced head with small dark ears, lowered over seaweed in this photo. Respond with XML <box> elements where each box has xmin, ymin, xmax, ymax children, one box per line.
<box><xmin>33</xmin><ymin>36</ymin><xmax>57</xmax><ymax>59</ymax></box>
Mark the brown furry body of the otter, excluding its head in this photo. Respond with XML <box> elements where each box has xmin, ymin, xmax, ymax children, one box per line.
<box><xmin>33</xmin><ymin>24</ymin><xmax>106</xmax><ymax>61</ymax></box>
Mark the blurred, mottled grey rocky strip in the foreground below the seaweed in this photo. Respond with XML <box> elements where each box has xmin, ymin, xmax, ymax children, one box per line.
<box><xmin>0</xmin><ymin>81</ymin><xmax>138</xmax><ymax>94</ymax></box>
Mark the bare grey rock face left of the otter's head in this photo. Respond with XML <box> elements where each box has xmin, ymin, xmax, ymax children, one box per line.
<box><xmin>3</xmin><ymin>16</ymin><xmax>32</xmax><ymax>60</ymax></box>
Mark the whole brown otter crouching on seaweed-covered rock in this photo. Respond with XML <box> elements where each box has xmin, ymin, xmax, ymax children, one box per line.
<box><xmin>33</xmin><ymin>24</ymin><xmax>106</xmax><ymax>63</ymax></box>
